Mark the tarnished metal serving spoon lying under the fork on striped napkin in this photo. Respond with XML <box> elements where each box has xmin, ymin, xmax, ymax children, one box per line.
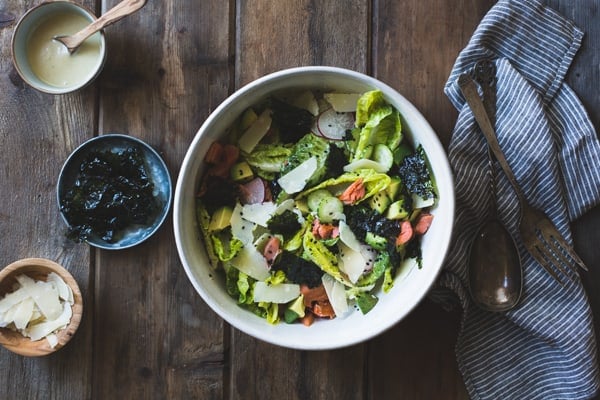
<box><xmin>469</xmin><ymin>61</ymin><xmax>523</xmax><ymax>311</ymax></box>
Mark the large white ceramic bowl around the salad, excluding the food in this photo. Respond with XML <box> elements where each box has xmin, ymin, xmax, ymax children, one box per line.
<box><xmin>173</xmin><ymin>67</ymin><xmax>454</xmax><ymax>350</ymax></box>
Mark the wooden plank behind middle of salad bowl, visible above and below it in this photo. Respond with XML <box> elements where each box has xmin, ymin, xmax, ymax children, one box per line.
<box><xmin>230</xmin><ymin>0</ymin><xmax>370</xmax><ymax>400</ymax></box>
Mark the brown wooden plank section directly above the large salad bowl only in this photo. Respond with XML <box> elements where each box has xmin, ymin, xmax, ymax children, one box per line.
<box><xmin>235</xmin><ymin>0</ymin><xmax>370</xmax><ymax>83</ymax></box>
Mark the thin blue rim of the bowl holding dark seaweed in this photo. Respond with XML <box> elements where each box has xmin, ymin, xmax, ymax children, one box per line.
<box><xmin>56</xmin><ymin>133</ymin><xmax>173</xmax><ymax>250</ymax></box>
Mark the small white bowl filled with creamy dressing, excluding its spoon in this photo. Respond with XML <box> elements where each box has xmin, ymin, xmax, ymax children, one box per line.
<box><xmin>12</xmin><ymin>1</ymin><xmax>106</xmax><ymax>94</ymax></box>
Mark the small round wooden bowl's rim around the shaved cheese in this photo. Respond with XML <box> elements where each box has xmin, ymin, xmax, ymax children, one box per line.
<box><xmin>0</xmin><ymin>257</ymin><xmax>83</xmax><ymax>357</ymax></box>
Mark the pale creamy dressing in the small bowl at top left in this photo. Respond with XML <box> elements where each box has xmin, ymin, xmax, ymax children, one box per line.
<box><xmin>26</xmin><ymin>13</ymin><xmax>102</xmax><ymax>87</ymax></box>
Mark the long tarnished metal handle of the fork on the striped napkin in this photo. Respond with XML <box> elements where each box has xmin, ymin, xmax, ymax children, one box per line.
<box><xmin>458</xmin><ymin>74</ymin><xmax>525</xmax><ymax>204</ymax></box>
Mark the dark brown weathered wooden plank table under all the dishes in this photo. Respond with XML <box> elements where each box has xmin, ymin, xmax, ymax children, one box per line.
<box><xmin>0</xmin><ymin>0</ymin><xmax>600</xmax><ymax>399</ymax></box>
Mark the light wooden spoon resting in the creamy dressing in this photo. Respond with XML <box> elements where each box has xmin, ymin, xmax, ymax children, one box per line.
<box><xmin>53</xmin><ymin>0</ymin><xmax>148</xmax><ymax>54</ymax></box>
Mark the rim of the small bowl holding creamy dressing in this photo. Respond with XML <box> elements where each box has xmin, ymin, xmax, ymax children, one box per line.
<box><xmin>10</xmin><ymin>0</ymin><xmax>108</xmax><ymax>95</ymax></box>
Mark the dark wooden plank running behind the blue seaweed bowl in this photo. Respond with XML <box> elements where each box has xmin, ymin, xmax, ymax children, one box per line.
<box><xmin>93</xmin><ymin>0</ymin><xmax>233</xmax><ymax>399</ymax></box>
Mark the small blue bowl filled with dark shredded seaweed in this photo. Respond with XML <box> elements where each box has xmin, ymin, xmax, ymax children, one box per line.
<box><xmin>58</xmin><ymin>134</ymin><xmax>171</xmax><ymax>249</ymax></box>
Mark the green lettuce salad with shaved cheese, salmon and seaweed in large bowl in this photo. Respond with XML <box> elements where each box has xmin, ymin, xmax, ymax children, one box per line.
<box><xmin>196</xmin><ymin>89</ymin><xmax>437</xmax><ymax>325</ymax></box>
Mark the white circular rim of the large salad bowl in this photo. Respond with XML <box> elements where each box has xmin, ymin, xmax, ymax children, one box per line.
<box><xmin>173</xmin><ymin>66</ymin><xmax>455</xmax><ymax>350</ymax></box>
